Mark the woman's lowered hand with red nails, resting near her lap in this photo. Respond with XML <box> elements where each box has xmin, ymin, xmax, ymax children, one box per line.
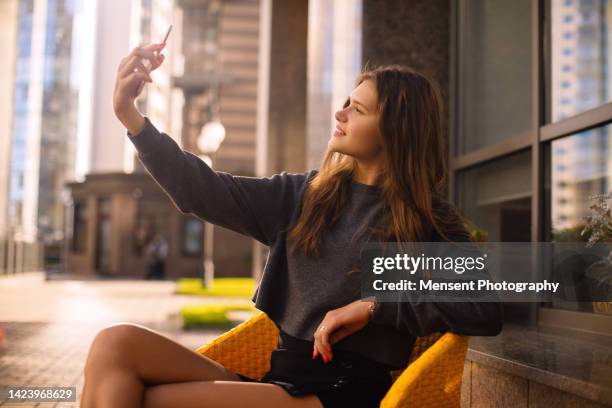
<box><xmin>312</xmin><ymin>299</ymin><xmax>373</xmax><ymax>363</ymax></box>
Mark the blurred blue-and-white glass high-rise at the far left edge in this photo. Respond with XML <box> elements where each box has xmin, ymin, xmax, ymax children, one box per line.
<box><xmin>0</xmin><ymin>0</ymin><xmax>89</xmax><ymax>272</ymax></box>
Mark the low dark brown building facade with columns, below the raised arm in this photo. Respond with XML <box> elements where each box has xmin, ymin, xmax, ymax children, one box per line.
<box><xmin>68</xmin><ymin>172</ymin><xmax>202</xmax><ymax>279</ymax></box>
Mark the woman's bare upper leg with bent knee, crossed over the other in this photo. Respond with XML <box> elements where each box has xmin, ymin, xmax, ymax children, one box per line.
<box><xmin>81</xmin><ymin>324</ymin><xmax>245</xmax><ymax>408</ymax></box>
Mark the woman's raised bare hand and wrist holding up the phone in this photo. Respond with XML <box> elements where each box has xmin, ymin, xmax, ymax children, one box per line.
<box><xmin>113</xmin><ymin>44</ymin><xmax>164</xmax><ymax>135</ymax></box>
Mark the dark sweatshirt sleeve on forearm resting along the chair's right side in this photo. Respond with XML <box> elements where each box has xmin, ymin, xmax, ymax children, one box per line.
<box><xmin>371</xmin><ymin>228</ymin><xmax>504</xmax><ymax>336</ymax></box>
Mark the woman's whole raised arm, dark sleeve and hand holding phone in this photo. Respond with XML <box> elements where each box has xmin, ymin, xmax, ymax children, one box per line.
<box><xmin>113</xmin><ymin>44</ymin><xmax>308</xmax><ymax>245</ymax></box>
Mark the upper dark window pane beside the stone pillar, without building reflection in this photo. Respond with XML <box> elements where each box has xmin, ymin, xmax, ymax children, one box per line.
<box><xmin>455</xmin><ymin>0</ymin><xmax>533</xmax><ymax>154</ymax></box>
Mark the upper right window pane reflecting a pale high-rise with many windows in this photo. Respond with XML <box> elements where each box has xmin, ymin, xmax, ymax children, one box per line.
<box><xmin>546</xmin><ymin>0</ymin><xmax>612</xmax><ymax>122</ymax></box>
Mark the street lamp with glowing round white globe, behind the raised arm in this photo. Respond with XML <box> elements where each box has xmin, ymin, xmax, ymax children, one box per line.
<box><xmin>197</xmin><ymin>120</ymin><xmax>225</xmax><ymax>288</ymax></box>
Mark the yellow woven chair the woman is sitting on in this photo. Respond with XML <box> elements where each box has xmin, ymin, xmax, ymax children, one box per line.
<box><xmin>196</xmin><ymin>312</ymin><xmax>469</xmax><ymax>408</ymax></box>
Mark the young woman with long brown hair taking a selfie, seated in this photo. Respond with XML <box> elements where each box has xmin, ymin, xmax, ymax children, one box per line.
<box><xmin>82</xmin><ymin>45</ymin><xmax>502</xmax><ymax>408</ymax></box>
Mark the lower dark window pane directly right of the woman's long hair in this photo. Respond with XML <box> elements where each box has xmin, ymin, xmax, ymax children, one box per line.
<box><xmin>458</xmin><ymin>152</ymin><xmax>531</xmax><ymax>242</ymax></box>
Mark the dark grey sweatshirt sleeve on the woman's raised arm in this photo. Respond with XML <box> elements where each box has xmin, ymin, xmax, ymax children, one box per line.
<box><xmin>127</xmin><ymin>118</ymin><xmax>307</xmax><ymax>246</ymax></box>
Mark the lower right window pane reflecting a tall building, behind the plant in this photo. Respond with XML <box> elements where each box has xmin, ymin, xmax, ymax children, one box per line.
<box><xmin>546</xmin><ymin>125</ymin><xmax>612</xmax><ymax>315</ymax></box>
